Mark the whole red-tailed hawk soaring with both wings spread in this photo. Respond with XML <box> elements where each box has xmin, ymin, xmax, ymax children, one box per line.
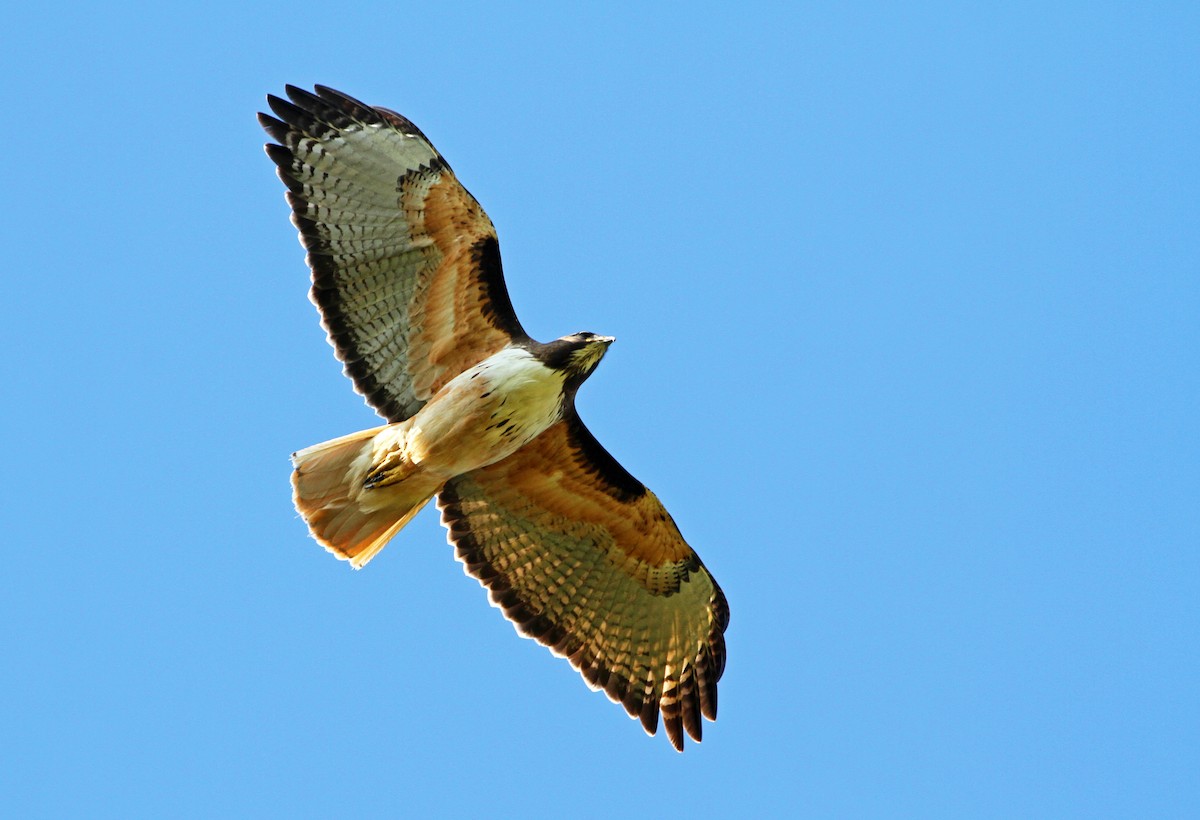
<box><xmin>259</xmin><ymin>85</ymin><xmax>728</xmax><ymax>750</ymax></box>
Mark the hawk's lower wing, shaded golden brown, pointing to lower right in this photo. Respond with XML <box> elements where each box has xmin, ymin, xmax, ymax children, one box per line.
<box><xmin>438</xmin><ymin>409</ymin><xmax>730</xmax><ymax>749</ymax></box>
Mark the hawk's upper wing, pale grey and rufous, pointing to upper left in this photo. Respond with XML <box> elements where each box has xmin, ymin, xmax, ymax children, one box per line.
<box><xmin>258</xmin><ymin>85</ymin><xmax>527</xmax><ymax>421</ymax></box>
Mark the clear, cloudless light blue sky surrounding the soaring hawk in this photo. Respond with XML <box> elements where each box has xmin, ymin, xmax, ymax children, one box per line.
<box><xmin>0</xmin><ymin>0</ymin><xmax>1200</xmax><ymax>818</ymax></box>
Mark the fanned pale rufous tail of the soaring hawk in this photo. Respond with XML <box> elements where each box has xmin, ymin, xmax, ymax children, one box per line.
<box><xmin>292</xmin><ymin>427</ymin><xmax>438</xmax><ymax>569</ymax></box>
